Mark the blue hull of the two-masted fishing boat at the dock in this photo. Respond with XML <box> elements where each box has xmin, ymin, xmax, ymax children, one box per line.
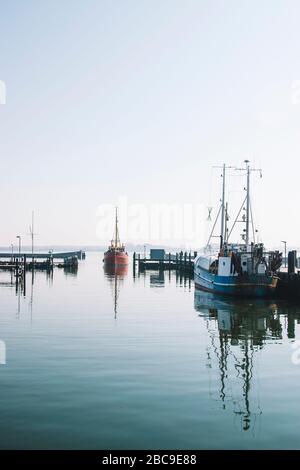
<box><xmin>194</xmin><ymin>266</ymin><xmax>277</xmax><ymax>298</ymax></box>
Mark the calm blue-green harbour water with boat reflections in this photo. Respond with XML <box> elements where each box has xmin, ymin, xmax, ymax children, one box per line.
<box><xmin>0</xmin><ymin>253</ymin><xmax>300</xmax><ymax>449</ymax></box>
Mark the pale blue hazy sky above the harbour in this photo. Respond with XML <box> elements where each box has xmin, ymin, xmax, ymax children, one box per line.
<box><xmin>0</xmin><ymin>0</ymin><xmax>300</xmax><ymax>248</ymax></box>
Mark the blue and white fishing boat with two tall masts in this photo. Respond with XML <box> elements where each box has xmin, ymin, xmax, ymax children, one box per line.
<box><xmin>194</xmin><ymin>160</ymin><xmax>282</xmax><ymax>298</ymax></box>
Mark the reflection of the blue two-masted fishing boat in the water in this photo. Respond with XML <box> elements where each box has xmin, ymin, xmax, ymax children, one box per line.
<box><xmin>194</xmin><ymin>289</ymin><xmax>284</xmax><ymax>431</ymax></box>
